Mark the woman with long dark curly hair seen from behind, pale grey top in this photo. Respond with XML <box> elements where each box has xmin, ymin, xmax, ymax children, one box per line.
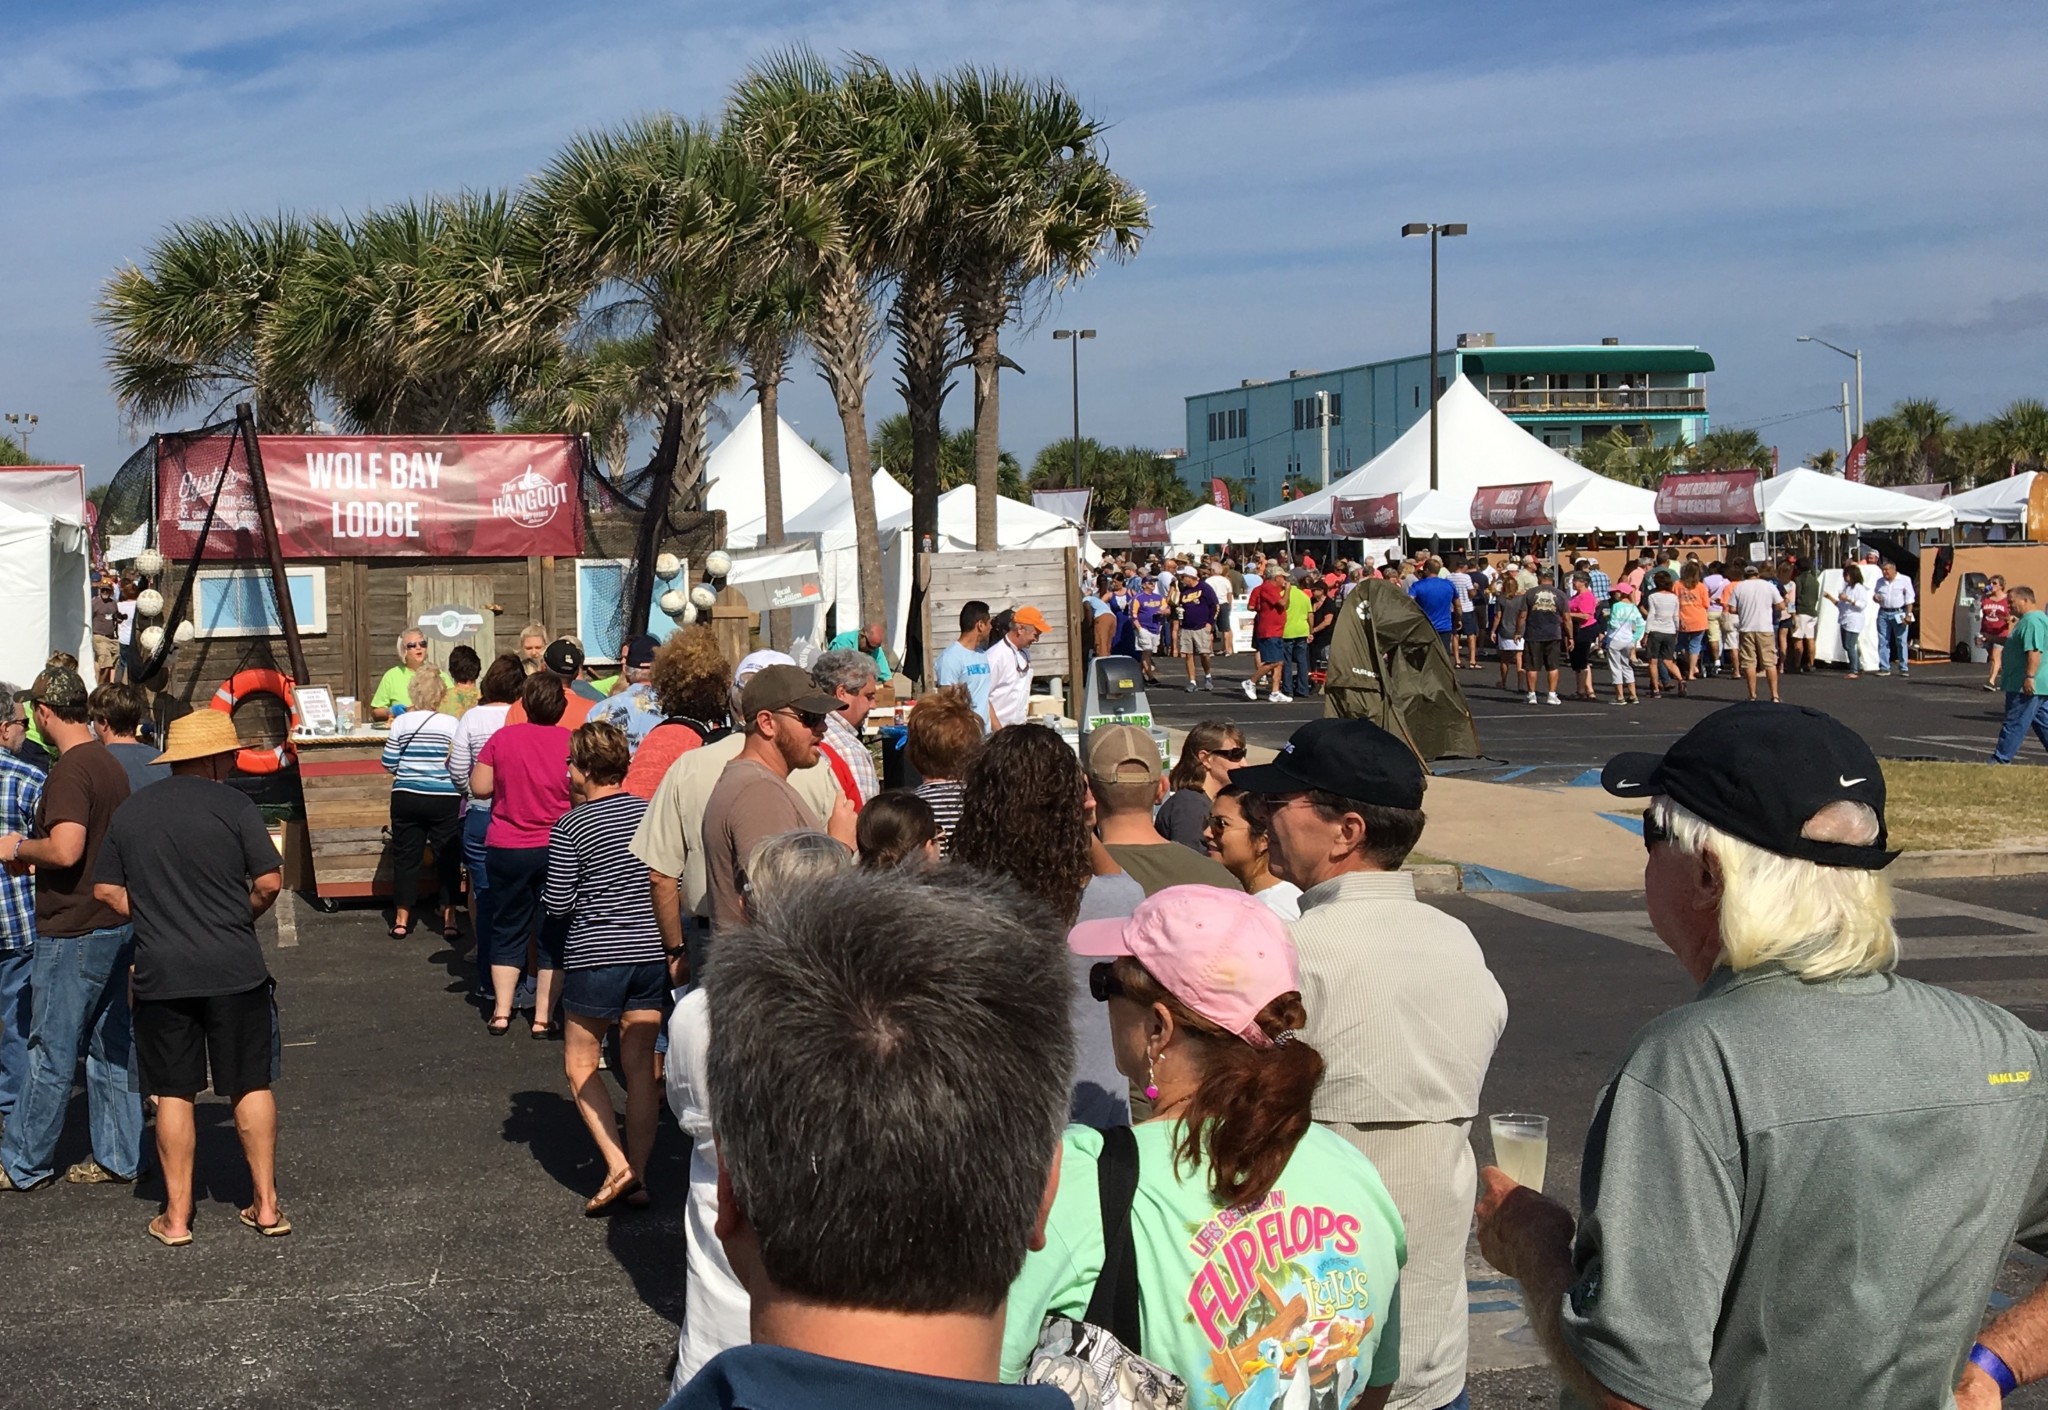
<box><xmin>952</xmin><ymin>723</ymin><xmax>1145</xmax><ymax>1127</ymax></box>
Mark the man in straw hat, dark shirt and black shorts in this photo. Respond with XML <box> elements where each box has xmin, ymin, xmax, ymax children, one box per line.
<box><xmin>92</xmin><ymin>709</ymin><xmax>291</xmax><ymax>1248</ymax></box>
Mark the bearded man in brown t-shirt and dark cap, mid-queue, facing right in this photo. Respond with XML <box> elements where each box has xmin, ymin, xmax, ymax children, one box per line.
<box><xmin>705</xmin><ymin>666</ymin><xmax>854</xmax><ymax>935</ymax></box>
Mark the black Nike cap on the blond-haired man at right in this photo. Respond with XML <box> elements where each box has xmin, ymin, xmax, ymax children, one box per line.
<box><xmin>1597</xmin><ymin>701</ymin><xmax>1898</xmax><ymax>871</ymax></box>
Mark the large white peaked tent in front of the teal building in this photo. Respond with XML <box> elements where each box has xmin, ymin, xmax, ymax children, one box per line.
<box><xmin>1253</xmin><ymin>377</ymin><xmax>1657</xmax><ymax>539</ymax></box>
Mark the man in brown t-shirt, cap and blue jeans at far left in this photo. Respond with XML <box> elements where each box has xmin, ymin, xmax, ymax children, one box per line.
<box><xmin>0</xmin><ymin>666</ymin><xmax>141</xmax><ymax>1191</ymax></box>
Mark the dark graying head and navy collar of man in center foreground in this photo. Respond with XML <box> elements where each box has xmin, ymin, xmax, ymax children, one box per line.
<box><xmin>666</xmin><ymin>871</ymin><xmax>1073</xmax><ymax>1410</ymax></box>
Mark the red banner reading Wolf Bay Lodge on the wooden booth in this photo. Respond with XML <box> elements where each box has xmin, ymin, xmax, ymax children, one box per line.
<box><xmin>156</xmin><ymin>437</ymin><xmax>584</xmax><ymax>559</ymax></box>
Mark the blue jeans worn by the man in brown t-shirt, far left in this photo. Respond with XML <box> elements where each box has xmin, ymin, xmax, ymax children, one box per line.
<box><xmin>0</xmin><ymin>924</ymin><xmax>141</xmax><ymax>1187</ymax></box>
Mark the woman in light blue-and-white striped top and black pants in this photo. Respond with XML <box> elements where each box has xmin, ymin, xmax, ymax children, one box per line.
<box><xmin>383</xmin><ymin>666</ymin><xmax>463</xmax><ymax>939</ymax></box>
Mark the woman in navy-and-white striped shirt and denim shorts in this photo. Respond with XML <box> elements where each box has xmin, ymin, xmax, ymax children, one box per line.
<box><xmin>541</xmin><ymin>719</ymin><xmax>668</xmax><ymax>1215</ymax></box>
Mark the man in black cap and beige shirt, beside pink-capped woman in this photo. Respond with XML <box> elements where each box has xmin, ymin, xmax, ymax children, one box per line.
<box><xmin>1231</xmin><ymin>719</ymin><xmax>1507</xmax><ymax>1410</ymax></box>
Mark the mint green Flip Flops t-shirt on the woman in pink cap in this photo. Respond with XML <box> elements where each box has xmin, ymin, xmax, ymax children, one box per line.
<box><xmin>1004</xmin><ymin>1121</ymin><xmax>1407</xmax><ymax>1410</ymax></box>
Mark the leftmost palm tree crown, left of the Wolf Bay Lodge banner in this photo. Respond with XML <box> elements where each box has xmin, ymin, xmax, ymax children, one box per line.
<box><xmin>94</xmin><ymin>213</ymin><xmax>313</xmax><ymax>430</ymax></box>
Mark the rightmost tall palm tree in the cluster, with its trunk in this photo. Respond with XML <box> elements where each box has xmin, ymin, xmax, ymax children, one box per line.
<box><xmin>946</xmin><ymin>70</ymin><xmax>1151</xmax><ymax>549</ymax></box>
